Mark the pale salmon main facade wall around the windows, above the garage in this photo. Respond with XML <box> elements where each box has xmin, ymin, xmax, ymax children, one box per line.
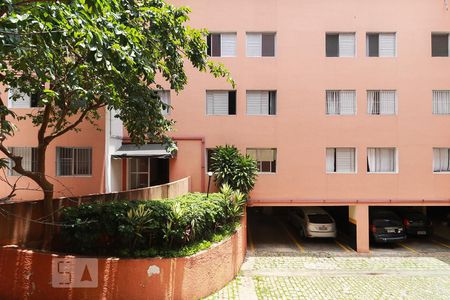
<box><xmin>166</xmin><ymin>0</ymin><xmax>450</xmax><ymax>200</ymax></box>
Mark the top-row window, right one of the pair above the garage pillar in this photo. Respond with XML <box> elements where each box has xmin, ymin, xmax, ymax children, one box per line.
<box><xmin>366</xmin><ymin>33</ymin><xmax>397</xmax><ymax>57</ymax></box>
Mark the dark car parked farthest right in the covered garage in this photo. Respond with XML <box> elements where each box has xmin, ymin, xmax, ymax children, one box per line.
<box><xmin>398</xmin><ymin>208</ymin><xmax>433</xmax><ymax>236</ymax></box>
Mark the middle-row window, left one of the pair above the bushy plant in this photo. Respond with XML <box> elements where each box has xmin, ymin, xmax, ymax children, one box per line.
<box><xmin>206</xmin><ymin>91</ymin><xmax>236</xmax><ymax>116</ymax></box>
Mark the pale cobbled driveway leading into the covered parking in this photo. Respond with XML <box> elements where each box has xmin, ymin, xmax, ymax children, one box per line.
<box><xmin>208</xmin><ymin>212</ymin><xmax>450</xmax><ymax>300</ymax></box>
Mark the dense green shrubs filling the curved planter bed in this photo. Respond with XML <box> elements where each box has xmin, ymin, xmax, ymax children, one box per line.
<box><xmin>57</xmin><ymin>190</ymin><xmax>245</xmax><ymax>257</ymax></box>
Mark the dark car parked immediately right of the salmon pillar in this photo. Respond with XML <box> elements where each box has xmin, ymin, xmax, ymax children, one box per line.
<box><xmin>369</xmin><ymin>208</ymin><xmax>406</xmax><ymax>243</ymax></box>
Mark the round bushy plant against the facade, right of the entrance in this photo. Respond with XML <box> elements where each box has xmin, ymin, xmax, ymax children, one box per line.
<box><xmin>211</xmin><ymin>145</ymin><xmax>258</xmax><ymax>194</ymax></box>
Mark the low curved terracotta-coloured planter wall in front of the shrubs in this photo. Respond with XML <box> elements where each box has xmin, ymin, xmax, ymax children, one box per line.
<box><xmin>0</xmin><ymin>218</ymin><xmax>247</xmax><ymax>300</ymax></box>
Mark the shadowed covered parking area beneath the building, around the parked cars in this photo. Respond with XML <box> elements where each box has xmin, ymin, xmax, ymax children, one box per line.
<box><xmin>247</xmin><ymin>201</ymin><xmax>450</xmax><ymax>254</ymax></box>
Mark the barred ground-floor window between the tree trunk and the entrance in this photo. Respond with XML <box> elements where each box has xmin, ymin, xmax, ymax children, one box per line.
<box><xmin>56</xmin><ymin>147</ymin><xmax>92</xmax><ymax>176</ymax></box>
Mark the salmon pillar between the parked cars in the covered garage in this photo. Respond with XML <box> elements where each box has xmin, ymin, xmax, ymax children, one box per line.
<box><xmin>348</xmin><ymin>204</ymin><xmax>369</xmax><ymax>253</ymax></box>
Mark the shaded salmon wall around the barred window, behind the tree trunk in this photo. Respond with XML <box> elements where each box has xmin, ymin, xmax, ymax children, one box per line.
<box><xmin>0</xmin><ymin>88</ymin><xmax>105</xmax><ymax>200</ymax></box>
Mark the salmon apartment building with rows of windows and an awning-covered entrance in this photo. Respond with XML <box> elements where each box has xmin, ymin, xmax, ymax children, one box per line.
<box><xmin>1</xmin><ymin>0</ymin><xmax>450</xmax><ymax>251</ymax></box>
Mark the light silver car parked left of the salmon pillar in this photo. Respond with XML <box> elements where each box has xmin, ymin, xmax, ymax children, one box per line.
<box><xmin>288</xmin><ymin>207</ymin><xmax>336</xmax><ymax>238</ymax></box>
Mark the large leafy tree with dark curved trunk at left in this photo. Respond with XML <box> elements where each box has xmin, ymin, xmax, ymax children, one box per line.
<box><xmin>0</xmin><ymin>0</ymin><xmax>234</xmax><ymax>248</ymax></box>
